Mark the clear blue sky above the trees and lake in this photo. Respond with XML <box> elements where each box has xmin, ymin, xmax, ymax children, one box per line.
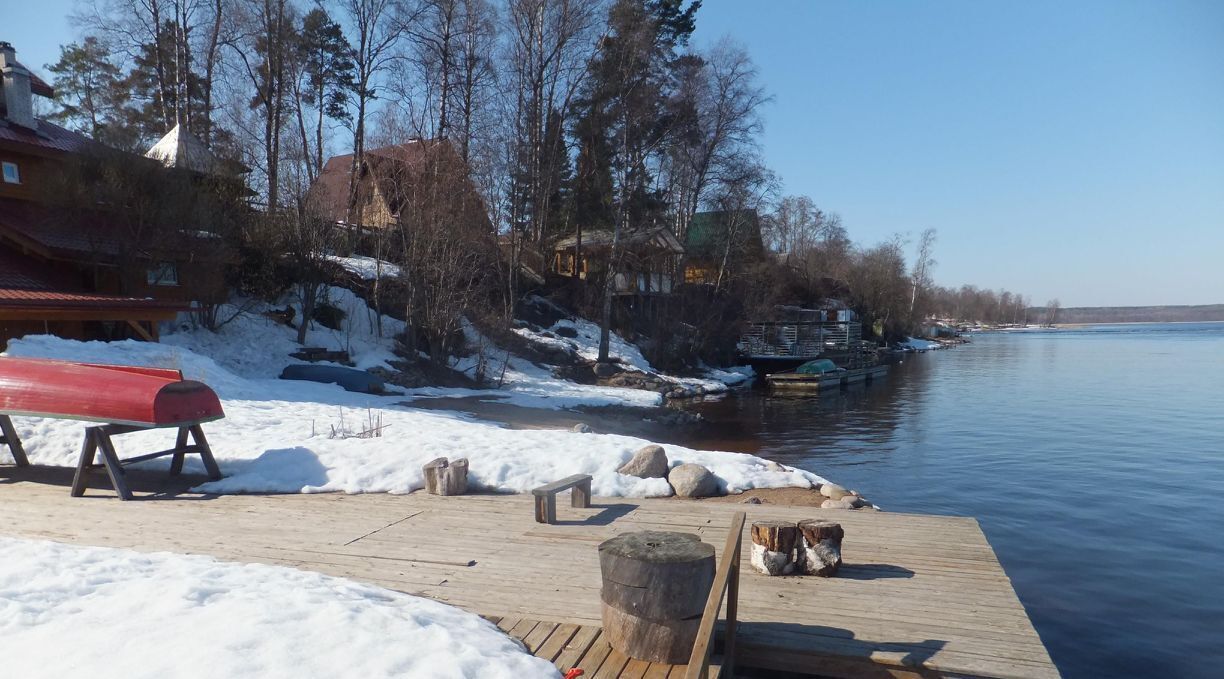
<box><xmin>0</xmin><ymin>0</ymin><xmax>1224</xmax><ymax>306</ymax></box>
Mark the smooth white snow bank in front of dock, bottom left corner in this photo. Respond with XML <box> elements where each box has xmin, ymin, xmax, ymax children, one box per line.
<box><xmin>0</xmin><ymin>537</ymin><xmax>558</xmax><ymax>679</ymax></box>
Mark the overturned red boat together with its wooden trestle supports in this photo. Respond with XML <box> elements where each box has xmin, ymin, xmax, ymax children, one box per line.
<box><xmin>0</xmin><ymin>357</ymin><xmax>225</xmax><ymax>500</ymax></box>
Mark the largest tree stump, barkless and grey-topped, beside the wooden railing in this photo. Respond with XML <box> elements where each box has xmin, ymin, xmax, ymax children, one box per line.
<box><xmin>600</xmin><ymin>531</ymin><xmax>715</xmax><ymax>664</ymax></box>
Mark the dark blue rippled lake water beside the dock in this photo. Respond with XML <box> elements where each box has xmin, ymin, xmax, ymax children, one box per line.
<box><xmin>685</xmin><ymin>323</ymin><xmax>1224</xmax><ymax>678</ymax></box>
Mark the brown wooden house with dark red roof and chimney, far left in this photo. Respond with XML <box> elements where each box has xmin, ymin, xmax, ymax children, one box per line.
<box><xmin>0</xmin><ymin>42</ymin><xmax>231</xmax><ymax>347</ymax></box>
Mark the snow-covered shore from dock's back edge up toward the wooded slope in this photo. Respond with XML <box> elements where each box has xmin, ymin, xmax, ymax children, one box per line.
<box><xmin>0</xmin><ymin>289</ymin><xmax>824</xmax><ymax>497</ymax></box>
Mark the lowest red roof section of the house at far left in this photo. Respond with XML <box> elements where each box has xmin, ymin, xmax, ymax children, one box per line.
<box><xmin>0</xmin><ymin>247</ymin><xmax>185</xmax><ymax>310</ymax></box>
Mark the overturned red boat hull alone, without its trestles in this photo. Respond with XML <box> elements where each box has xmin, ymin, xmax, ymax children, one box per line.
<box><xmin>0</xmin><ymin>357</ymin><xmax>225</xmax><ymax>427</ymax></box>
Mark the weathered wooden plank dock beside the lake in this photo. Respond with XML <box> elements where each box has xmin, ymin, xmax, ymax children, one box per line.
<box><xmin>0</xmin><ymin>466</ymin><xmax>1059</xmax><ymax>679</ymax></box>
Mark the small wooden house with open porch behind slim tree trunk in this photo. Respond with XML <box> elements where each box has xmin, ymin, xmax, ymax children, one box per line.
<box><xmin>552</xmin><ymin>226</ymin><xmax>684</xmax><ymax>295</ymax></box>
